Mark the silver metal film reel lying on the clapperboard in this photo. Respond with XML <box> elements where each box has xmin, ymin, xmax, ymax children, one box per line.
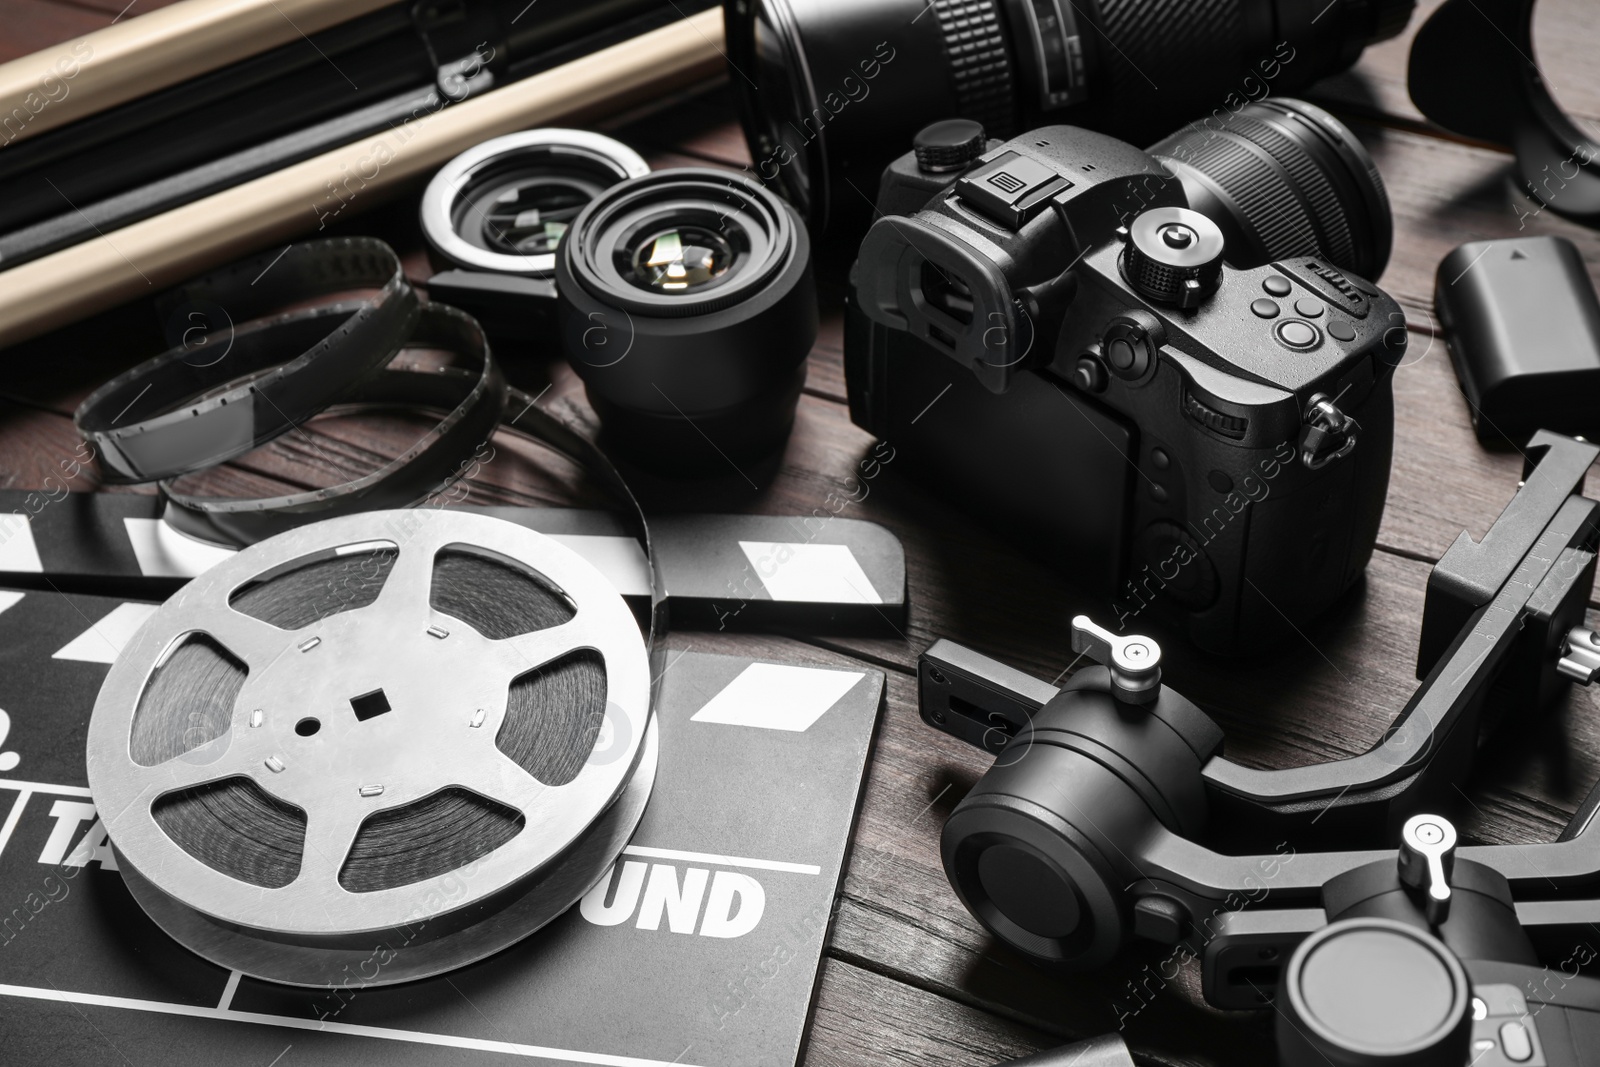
<box><xmin>88</xmin><ymin>510</ymin><xmax>654</xmax><ymax>985</ymax></box>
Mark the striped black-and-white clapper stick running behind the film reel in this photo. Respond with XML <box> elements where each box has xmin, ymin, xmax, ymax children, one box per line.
<box><xmin>0</xmin><ymin>490</ymin><xmax>906</xmax><ymax>632</ymax></box>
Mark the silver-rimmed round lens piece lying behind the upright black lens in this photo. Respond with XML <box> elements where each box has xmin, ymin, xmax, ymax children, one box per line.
<box><xmin>422</xmin><ymin>130</ymin><xmax>650</xmax><ymax>342</ymax></box>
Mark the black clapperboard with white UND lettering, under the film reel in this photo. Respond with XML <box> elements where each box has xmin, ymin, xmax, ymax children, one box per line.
<box><xmin>0</xmin><ymin>494</ymin><xmax>904</xmax><ymax>1067</ymax></box>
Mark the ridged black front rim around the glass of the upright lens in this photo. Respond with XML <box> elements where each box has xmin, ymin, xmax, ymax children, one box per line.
<box><xmin>558</xmin><ymin>168</ymin><xmax>800</xmax><ymax>318</ymax></box>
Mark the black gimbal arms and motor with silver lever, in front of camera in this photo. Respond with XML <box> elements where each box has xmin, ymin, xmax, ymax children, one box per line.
<box><xmin>920</xmin><ymin>434</ymin><xmax>1600</xmax><ymax>1008</ymax></box>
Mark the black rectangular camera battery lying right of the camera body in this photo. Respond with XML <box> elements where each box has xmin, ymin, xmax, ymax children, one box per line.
<box><xmin>1434</xmin><ymin>237</ymin><xmax>1600</xmax><ymax>445</ymax></box>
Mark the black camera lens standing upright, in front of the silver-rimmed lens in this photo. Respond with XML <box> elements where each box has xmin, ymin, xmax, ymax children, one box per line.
<box><xmin>555</xmin><ymin>168</ymin><xmax>818</xmax><ymax>472</ymax></box>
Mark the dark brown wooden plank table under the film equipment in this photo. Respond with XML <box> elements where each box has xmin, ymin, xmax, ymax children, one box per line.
<box><xmin>0</xmin><ymin>0</ymin><xmax>1600</xmax><ymax>1067</ymax></box>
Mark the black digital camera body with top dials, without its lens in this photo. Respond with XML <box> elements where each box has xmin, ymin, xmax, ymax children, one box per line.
<box><xmin>845</xmin><ymin>120</ymin><xmax>1406</xmax><ymax>654</ymax></box>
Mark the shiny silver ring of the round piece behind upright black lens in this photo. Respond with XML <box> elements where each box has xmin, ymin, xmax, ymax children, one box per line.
<box><xmin>422</xmin><ymin>128</ymin><xmax>650</xmax><ymax>277</ymax></box>
